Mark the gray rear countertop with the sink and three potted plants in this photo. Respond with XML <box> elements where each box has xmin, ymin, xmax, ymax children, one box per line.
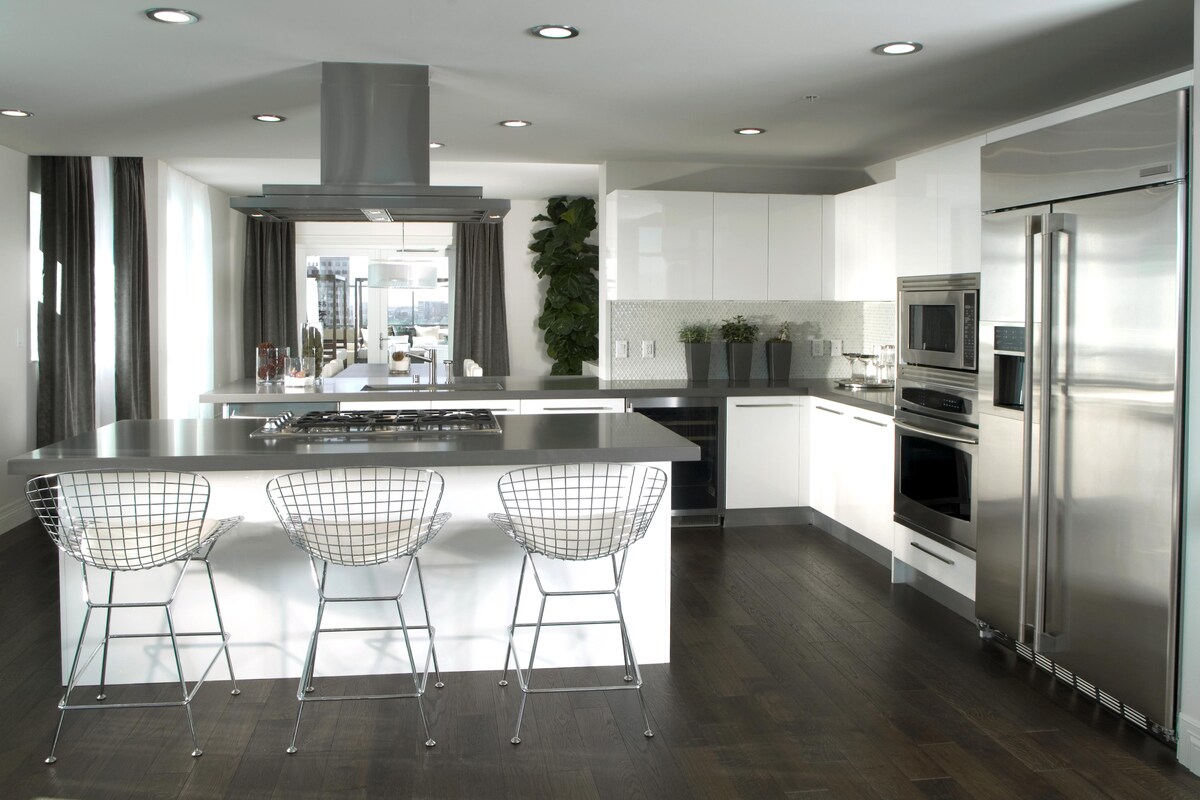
<box><xmin>200</xmin><ymin>363</ymin><xmax>894</xmax><ymax>415</ymax></box>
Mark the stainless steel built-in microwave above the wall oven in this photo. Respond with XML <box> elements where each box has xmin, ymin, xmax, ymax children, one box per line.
<box><xmin>896</xmin><ymin>272</ymin><xmax>979</xmax><ymax>372</ymax></box>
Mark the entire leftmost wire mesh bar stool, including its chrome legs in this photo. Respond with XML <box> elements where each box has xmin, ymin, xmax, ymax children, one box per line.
<box><xmin>25</xmin><ymin>469</ymin><xmax>242</xmax><ymax>764</ymax></box>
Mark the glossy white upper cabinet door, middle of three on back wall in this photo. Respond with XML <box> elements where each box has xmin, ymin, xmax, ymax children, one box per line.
<box><xmin>713</xmin><ymin>193</ymin><xmax>768</xmax><ymax>300</ymax></box>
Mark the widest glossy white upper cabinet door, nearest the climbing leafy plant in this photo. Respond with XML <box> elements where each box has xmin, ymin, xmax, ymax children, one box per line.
<box><xmin>608</xmin><ymin>191</ymin><xmax>713</xmax><ymax>300</ymax></box>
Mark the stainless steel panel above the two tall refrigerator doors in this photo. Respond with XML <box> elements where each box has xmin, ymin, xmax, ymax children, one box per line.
<box><xmin>980</xmin><ymin>90</ymin><xmax>1188</xmax><ymax>212</ymax></box>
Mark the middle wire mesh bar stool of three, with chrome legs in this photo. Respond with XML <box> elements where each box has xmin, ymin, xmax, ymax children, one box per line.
<box><xmin>266</xmin><ymin>467</ymin><xmax>450</xmax><ymax>753</ymax></box>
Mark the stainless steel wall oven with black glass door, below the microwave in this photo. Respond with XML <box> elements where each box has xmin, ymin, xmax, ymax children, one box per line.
<box><xmin>893</xmin><ymin>365</ymin><xmax>979</xmax><ymax>555</ymax></box>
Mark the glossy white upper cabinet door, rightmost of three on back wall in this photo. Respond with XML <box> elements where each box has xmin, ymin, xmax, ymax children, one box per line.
<box><xmin>767</xmin><ymin>194</ymin><xmax>827</xmax><ymax>300</ymax></box>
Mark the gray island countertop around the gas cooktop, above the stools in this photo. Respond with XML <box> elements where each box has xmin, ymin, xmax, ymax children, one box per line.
<box><xmin>8</xmin><ymin>414</ymin><xmax>700</xmax><ymax>475</ymax></box>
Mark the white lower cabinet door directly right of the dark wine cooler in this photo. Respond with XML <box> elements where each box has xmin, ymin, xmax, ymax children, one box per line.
<box><xmin>725</xmin><ymin>397</ymin><xmax>808</xmax><ymax>509</ymax></box>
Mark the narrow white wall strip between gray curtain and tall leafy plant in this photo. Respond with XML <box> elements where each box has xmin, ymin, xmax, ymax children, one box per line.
<box><xmin>504</xmin><ymin>200</ymin><xmax>554</xmax><ymax>377</ymax></box>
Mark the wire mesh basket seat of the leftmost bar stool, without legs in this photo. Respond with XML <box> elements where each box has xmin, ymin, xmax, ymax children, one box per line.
<box><xmin>25</xmin><ymin>469</ymin><xmax>214</xmax><ymax>570</ymax></box>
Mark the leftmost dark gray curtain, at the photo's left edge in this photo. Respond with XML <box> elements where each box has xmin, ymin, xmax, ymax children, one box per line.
<box><xmin>36</xmin><ymin>156</ymin><xmax>96</xmax><ymax>447</ymax></box>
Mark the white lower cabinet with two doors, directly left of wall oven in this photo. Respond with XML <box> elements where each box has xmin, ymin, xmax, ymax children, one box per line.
<box><xmin>809</xmin><ymin>398</ymin><xmax>895</xmax><ymax>551</ymax></box>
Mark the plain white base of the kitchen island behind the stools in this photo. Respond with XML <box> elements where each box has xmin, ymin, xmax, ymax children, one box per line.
<box><xmin>59</xmin><ymin>463</ymin><xmax>671</xmax><ymax>685</ymax></box>
